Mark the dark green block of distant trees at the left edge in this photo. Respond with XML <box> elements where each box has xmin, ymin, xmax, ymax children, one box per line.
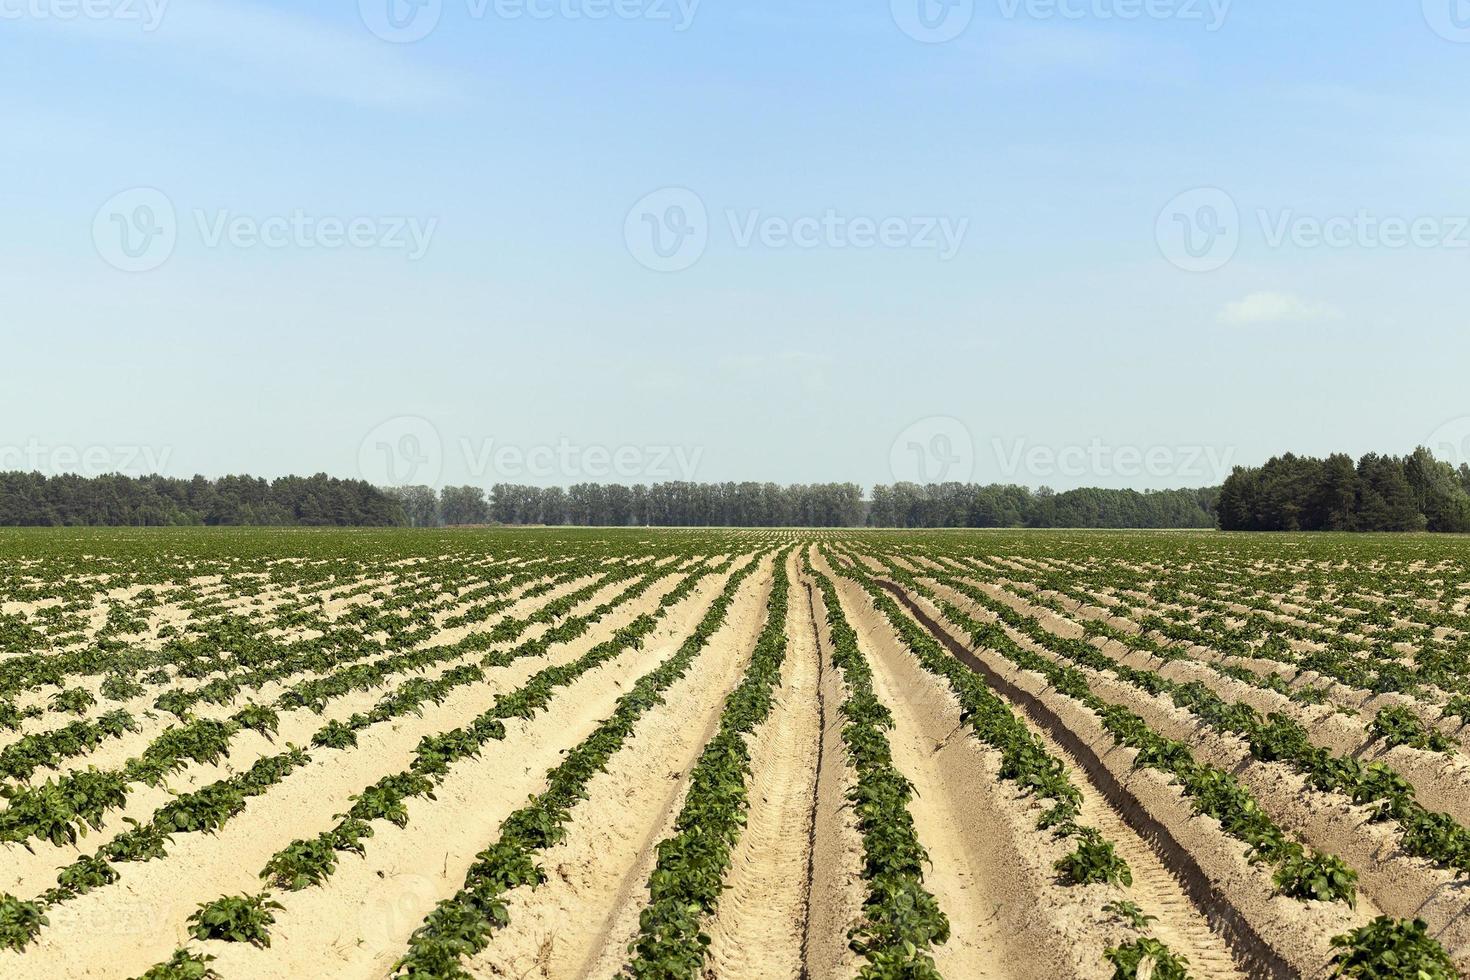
<box><xmin>0</xmin><ymin>473</ymin><xmax>403</xmax><ymax>527</ymax></box>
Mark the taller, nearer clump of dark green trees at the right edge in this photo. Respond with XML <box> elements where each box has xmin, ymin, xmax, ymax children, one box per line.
<box><xmin>1219</xmin><ymin>448</ymin><xmax>1470</xmax><ymax>532</ymax></box>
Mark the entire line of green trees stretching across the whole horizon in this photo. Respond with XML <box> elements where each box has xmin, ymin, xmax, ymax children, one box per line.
<box><xmin>0</xmin><ymin>450</ymin><xmax>1470</xmax><ymax>532</ymax></box>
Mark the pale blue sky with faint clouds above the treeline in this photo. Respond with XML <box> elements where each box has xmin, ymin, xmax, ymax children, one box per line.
<box><xmin>0</xmin><ymin>0</ymin><xmax>1470</xmax><ymax>488</ymax></box>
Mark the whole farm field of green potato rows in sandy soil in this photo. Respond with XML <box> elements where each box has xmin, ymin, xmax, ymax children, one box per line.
<box><xmin>0</xmin><ymin>529</ymin><xmax>1470</xmax><ymax>980</ymax></box>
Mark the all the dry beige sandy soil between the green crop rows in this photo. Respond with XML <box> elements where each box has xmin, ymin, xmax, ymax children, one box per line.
<box><xmin>0</xmin><ymin>532</ymin><xmax>1470</xmax><ymax>980</ymax></box>
